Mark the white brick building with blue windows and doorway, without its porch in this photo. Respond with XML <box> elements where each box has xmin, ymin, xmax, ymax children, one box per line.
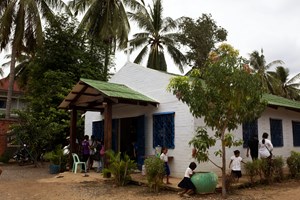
<box><xmin>85</xmin><ymin>62</ymin><xmax>300</xmax><ymax>177</ymax></box>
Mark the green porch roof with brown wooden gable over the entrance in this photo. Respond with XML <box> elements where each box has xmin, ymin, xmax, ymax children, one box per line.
<box><xmin>59</xmin><ymin>79</ymin><xmax>159</xmax><ymax>111</ymax></box>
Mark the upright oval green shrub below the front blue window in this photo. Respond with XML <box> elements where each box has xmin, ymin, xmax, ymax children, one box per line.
<box><xmin>145</xmin><ymin>156</ymin><xmax>165</xmax><ymax>192</ymax></box>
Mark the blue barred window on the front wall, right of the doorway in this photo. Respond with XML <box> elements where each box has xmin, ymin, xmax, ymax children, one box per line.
<box><xmin>153</xmin><ymin>112</ymin><xmax>175</xmax><ymax>149</ymax></box>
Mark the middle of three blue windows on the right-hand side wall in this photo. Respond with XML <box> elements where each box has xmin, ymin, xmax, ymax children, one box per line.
<box><xmin>270</xmin><ymin>118</ymin><xmax>283</xmax><ymax>147</ymax></box>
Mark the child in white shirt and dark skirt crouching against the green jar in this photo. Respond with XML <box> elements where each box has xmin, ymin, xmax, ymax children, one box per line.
<box><xmin>178</xmin><ymin>162</ymin><xmax>197</xmax><ymax>197</ymax></box>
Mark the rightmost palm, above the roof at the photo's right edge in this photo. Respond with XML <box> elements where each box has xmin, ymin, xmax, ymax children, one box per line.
<box><xmin>274</xmin><ymin>66</ymin><xmax>300</xmax><ymax>100</ymax></box>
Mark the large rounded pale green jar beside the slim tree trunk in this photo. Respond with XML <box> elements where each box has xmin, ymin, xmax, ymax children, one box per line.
<box><xmin>191</xmin><ymin>172</ymin><xmax>218</xmax><ymax>194</ymax></box>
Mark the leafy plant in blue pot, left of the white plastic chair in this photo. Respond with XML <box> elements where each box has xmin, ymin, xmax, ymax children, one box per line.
<box><xmin>44</xmin><ymin>145</ymin><xmax>64</xmax><ymax>174</ymax></box>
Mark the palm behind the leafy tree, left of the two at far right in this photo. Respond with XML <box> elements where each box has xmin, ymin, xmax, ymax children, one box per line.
<box><xmin>250</xmin><ymin>50</ymin><xmax>283</xmax><ymax>94</ymax></box>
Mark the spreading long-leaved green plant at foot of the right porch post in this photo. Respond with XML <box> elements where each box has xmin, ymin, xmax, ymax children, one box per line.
<box><xmin>103</xmin><ymin>150</ymin><xmax>136</xmax><ymax>186</ymax></box>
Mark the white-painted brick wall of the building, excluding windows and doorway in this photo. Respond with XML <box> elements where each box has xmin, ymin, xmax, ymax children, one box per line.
<box><xmin>85</xmin><ymin>63</ymin><xmax>300</xmax><ymax>177</ymax></box>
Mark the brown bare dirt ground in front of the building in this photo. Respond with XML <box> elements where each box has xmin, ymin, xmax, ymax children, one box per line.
<box><xmin>0</xmin><ymin>164</ymin><xmax>300</xmax><ymax>200</ymax></box>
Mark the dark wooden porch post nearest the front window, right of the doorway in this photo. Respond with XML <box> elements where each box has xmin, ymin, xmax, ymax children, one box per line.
<box><xmin>103</xmin><ymin>102</ymin><xmax>112</xmax><ymax>167</ymax></box>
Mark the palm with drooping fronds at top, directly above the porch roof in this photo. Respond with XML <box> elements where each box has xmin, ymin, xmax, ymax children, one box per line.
<box><xmin>69</xmin><ymin>0</ymin><xmax>143</xmax><ymax>77</ymax></box>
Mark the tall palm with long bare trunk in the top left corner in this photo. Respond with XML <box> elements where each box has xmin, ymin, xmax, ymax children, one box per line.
<box><xmin>0</xmin><ymin>0</ymin><xmax>67</xmax><ymax>119</ymax></box>
